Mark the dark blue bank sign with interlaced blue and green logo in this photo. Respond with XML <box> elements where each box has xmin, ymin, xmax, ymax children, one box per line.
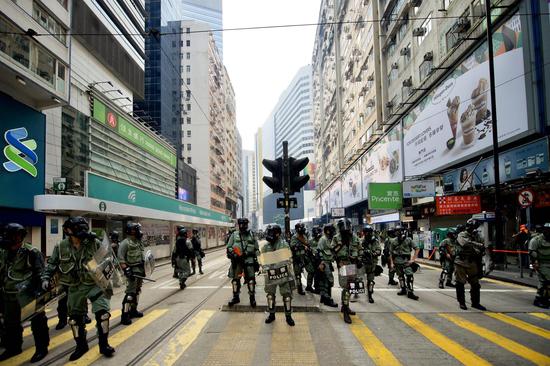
<box><xmin>0</xmin><ymin>94</ymin><xmax>46</xmax><ymax>209</ymax></box>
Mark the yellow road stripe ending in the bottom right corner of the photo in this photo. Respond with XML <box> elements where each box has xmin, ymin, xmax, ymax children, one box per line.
<box><xmin>439</xmin><ymin>314</ymin><xmax>550</xmax><ymax>365</ymax></box>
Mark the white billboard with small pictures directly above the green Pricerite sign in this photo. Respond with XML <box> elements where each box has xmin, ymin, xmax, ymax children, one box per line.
<box><xmin>361</xmin><ymin>125</ymin><xmax>403</xmax><ymax>199</ymax></box>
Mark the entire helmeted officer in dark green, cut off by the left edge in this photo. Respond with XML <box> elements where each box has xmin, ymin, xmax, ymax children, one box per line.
<box><xmin>0</xmin><ymin>223</ymin><xmax>50</xmax><ymax>363</ymax></box>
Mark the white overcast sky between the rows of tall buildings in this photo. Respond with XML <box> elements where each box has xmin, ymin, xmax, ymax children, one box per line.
<box><xmin>223</xmin><ymin>0</ymin><xmax>321</xmax><ymax>150</ymax></box>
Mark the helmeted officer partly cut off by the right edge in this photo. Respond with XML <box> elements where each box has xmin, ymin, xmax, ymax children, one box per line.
<box><xmin>529</xmin><ymin>223</ymin><xmax>550</xmax><ymax>309</ymax></box>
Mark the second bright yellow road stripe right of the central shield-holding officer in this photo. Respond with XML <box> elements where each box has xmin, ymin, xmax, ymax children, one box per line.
<box><xmin>395</xmin><ymin>313</ymin><xmax>490</xmax><ymax>365</ymax></box>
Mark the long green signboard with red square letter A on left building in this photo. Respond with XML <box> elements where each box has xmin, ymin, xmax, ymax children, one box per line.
<box><xmin>92</xmin><ymin>99</ymin><xmax>176</xmax><ymax>168</ymax></box>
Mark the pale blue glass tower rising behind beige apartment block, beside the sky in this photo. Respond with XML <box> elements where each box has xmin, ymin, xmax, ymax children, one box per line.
<box><xmin>180</xmin><ymin>0</ymin><xmax>223</xmax><ymax>61</ymax></box>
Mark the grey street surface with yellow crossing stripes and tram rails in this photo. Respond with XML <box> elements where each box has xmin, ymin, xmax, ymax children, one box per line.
<box><xmin>8</xmin><ymin>250</ymin><xmax>550</xmax><ymax>366</ymax></box>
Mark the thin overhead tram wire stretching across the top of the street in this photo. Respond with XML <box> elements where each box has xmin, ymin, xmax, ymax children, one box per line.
<box><xmin>0</xmin><ymin>12</ymin><xmax>550</xmax><ymax>37</ymax></box>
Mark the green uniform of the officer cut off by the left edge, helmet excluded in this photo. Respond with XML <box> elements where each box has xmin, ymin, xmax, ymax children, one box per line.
<box><xmin>0</xmin><ymin>243</ymin><xmax>50</xmax><ymax>351</ymax></box>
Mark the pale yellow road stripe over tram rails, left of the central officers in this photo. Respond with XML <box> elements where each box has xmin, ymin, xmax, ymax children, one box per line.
<box><xmin>144</xmin><ymin>310</ymin><xmax>215</xmax><ymax>366</ymax></box>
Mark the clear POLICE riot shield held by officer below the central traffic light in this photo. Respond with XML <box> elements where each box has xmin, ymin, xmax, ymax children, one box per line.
<box><xmin>260</xmin><ymin>248</ymin><xmax>296</xmax><ymax>288</ymax></box>
